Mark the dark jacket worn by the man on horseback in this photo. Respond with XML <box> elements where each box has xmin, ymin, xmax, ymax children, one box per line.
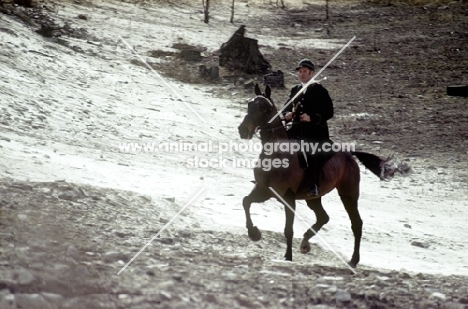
<box><xmin>283</xmin><ymin>83</ymin><xmax>333</xmax><ymax>142</ymax></box>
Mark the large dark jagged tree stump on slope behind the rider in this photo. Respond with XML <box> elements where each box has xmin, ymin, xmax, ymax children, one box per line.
<box><xmin>219</xmin><ymin>25</ymin><xmax>271</xmax><ymax>74</ymax></box>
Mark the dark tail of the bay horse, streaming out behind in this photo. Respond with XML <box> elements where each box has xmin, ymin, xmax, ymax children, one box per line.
<box><xmin>351</xmin><ymin>151</ymin><xmax>411</xmax><ymax>180</ymax></box>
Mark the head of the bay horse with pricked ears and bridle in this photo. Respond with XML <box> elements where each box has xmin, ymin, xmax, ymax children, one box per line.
<box><xmin>239</xmin><ymin>84</ymin><xmax>276</xmax><ymax>139</ymax></box>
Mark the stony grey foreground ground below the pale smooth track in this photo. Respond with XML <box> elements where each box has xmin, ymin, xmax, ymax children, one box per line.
<box><xmin>0</xmin><ymin>182</ymin><xmax>468</xmax><ymax>308</ymax></box>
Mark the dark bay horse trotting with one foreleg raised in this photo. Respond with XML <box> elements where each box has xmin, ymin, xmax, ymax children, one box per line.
<box><xmin>238</xmin><ymin>85</ymin><xmax>406</xmax><ymax>268</ymax></box>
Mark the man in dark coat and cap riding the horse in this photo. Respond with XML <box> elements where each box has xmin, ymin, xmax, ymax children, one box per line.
<box><xmin>283</xmin><ymin>59</ymin><xmax>333</xmax><ymax>196</ymax></box>
